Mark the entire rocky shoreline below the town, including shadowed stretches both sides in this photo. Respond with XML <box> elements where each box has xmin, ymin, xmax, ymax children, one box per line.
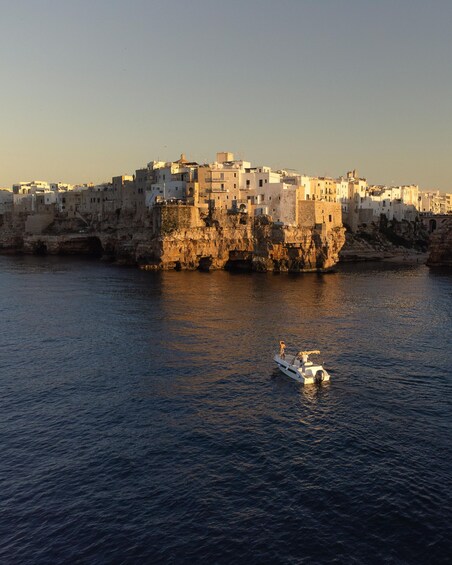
<box><xmin>0</xmin><ymin>212</ymin><xmax>447</xmax><ymax>272</ymax></box>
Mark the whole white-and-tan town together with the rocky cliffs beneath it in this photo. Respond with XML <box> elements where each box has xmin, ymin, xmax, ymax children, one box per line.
<box><xmin>0</xmin><ymin>152</ymin><xmax>452</xmax><ymax>272</ymax></box>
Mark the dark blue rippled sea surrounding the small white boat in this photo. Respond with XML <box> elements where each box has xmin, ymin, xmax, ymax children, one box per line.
<box><xmin>0</xmin><ymin>257</ymin><xmax>452</xmax><ymax>564</ymax></box>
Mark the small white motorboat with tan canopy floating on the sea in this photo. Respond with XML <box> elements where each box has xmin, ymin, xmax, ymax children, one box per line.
<box><xmin>273</xmin><ymin>349</ymin><xmax>330</xmax><ymax>385</ymax></box>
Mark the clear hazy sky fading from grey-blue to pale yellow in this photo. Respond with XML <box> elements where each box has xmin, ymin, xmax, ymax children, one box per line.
<box><xmin>0</xmin><ymin>0</ymin><xmax>452</xmax><ymax>192</ymax></box>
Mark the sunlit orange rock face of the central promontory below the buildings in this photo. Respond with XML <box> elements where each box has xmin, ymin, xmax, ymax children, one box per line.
<box><xmin>135</xmin><ymin>214</ymin><xmax>345</xmax><ymax>272</ymax></box>
